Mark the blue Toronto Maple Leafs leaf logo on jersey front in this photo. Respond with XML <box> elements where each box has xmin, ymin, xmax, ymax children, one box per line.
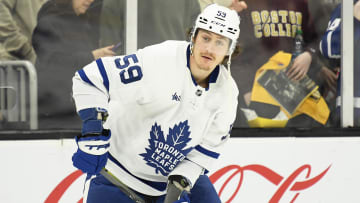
<box><xmin>139</xmin><ymin>120</ymin><xmax>192</xmax><ymax>176</ymax></box>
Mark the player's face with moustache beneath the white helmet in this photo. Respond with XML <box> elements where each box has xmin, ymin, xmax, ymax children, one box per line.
<box><xmin>193</xmin><ymin>29</ymin><xmax>230</xmax><ymax>74</ymax></box>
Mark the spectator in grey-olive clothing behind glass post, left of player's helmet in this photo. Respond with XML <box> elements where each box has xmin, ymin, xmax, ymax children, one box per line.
<box><xmin>100</xmin><ymin>0</ymin><xmax>200</xmax><ymax>54</ymax></box>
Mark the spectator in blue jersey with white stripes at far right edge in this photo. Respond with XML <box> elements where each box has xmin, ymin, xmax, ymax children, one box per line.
<box><xmin>320</xmin><ymin>0</ymin><xmax>360</xmax><ymax>126</ymax></box>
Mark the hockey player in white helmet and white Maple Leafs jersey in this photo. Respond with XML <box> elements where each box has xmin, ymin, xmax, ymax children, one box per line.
<box><xmin>72</xmin><ymin>4</ymin><xmax>240</xmax><ymax>203</ymax></box>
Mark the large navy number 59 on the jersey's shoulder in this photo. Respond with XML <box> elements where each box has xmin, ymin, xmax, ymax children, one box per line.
<box><xmin>115</xmin><ymin>54</ymin><xmax>142</xmax><ymax>84</ymax></box>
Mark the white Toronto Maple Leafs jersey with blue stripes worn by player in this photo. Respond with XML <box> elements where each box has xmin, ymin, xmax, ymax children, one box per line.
<box><xmin>73</xmin><ymin>41</ymin><xmax>238</xmax><ymax>196</ymax></box>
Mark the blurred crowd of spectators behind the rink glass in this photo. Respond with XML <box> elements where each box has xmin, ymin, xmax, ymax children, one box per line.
<box><xmin>0</xmin><ymin>0</ymin><xmax>360</xmax><ymax>129</ymax></box>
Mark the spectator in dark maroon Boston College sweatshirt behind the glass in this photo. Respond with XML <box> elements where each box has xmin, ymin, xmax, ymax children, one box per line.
<box><xmin>228</xmin><ymin>0</ymin><xmax>327</xmax><ymax>127</ymax></box>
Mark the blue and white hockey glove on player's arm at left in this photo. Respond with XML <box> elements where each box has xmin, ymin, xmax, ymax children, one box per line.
<box><xmin>72</xmin><ymin>108</ymin><xmax>111</xmax><ymax>174</ymax></box>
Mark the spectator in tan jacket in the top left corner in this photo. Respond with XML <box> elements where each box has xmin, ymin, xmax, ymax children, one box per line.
<box><xmin>0</xmin><ymin>0</ymin><xmax>45</xmax><ymax>64</ymax></box>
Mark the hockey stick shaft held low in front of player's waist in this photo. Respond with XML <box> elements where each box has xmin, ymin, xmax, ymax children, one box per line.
<box><xmin>100</xmin><ymin>168</ymin><xmax>145</xmax><ymax>203</ymax></box>
